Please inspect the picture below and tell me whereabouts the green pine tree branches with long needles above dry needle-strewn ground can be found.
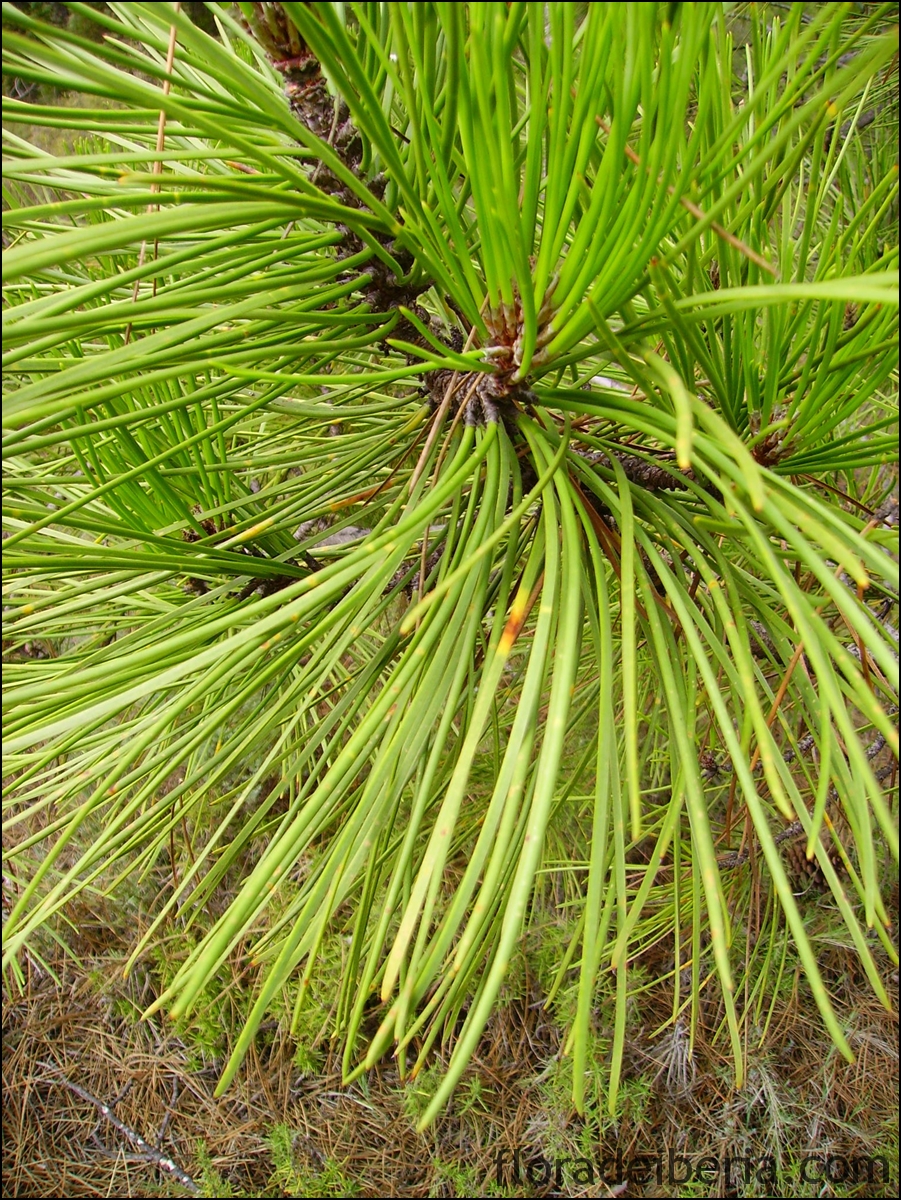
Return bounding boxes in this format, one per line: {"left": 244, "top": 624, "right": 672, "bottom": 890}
{"left": 4, "top": 2, "right": 899, "bottom": 1122}
